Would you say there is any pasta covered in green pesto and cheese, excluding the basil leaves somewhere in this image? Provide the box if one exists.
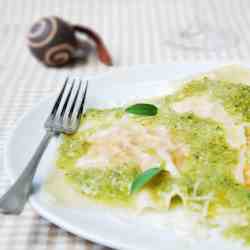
[56,67,250,245]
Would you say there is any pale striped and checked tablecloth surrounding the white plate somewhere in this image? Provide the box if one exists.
[0,0,250,250]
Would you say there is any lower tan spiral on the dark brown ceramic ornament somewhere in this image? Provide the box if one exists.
[44,43,74,66]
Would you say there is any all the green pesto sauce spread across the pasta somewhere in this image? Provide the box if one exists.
[57,78,250,243]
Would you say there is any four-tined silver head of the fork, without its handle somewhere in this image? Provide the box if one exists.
[45,77,88,134]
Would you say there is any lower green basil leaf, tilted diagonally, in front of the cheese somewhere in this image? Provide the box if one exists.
[130,167,164,193]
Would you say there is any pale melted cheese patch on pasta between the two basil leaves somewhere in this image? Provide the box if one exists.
[77,116,180,175]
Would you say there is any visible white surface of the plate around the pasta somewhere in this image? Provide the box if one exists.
[5,63,247,250]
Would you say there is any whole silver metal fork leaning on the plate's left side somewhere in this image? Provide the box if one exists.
[0,78,88,214]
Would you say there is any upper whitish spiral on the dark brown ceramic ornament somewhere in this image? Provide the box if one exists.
[28,17,58,48]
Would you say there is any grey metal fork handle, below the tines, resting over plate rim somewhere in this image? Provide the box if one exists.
[0,131,55,214]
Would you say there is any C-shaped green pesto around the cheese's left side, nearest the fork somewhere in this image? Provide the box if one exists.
[56,108,140,205]
